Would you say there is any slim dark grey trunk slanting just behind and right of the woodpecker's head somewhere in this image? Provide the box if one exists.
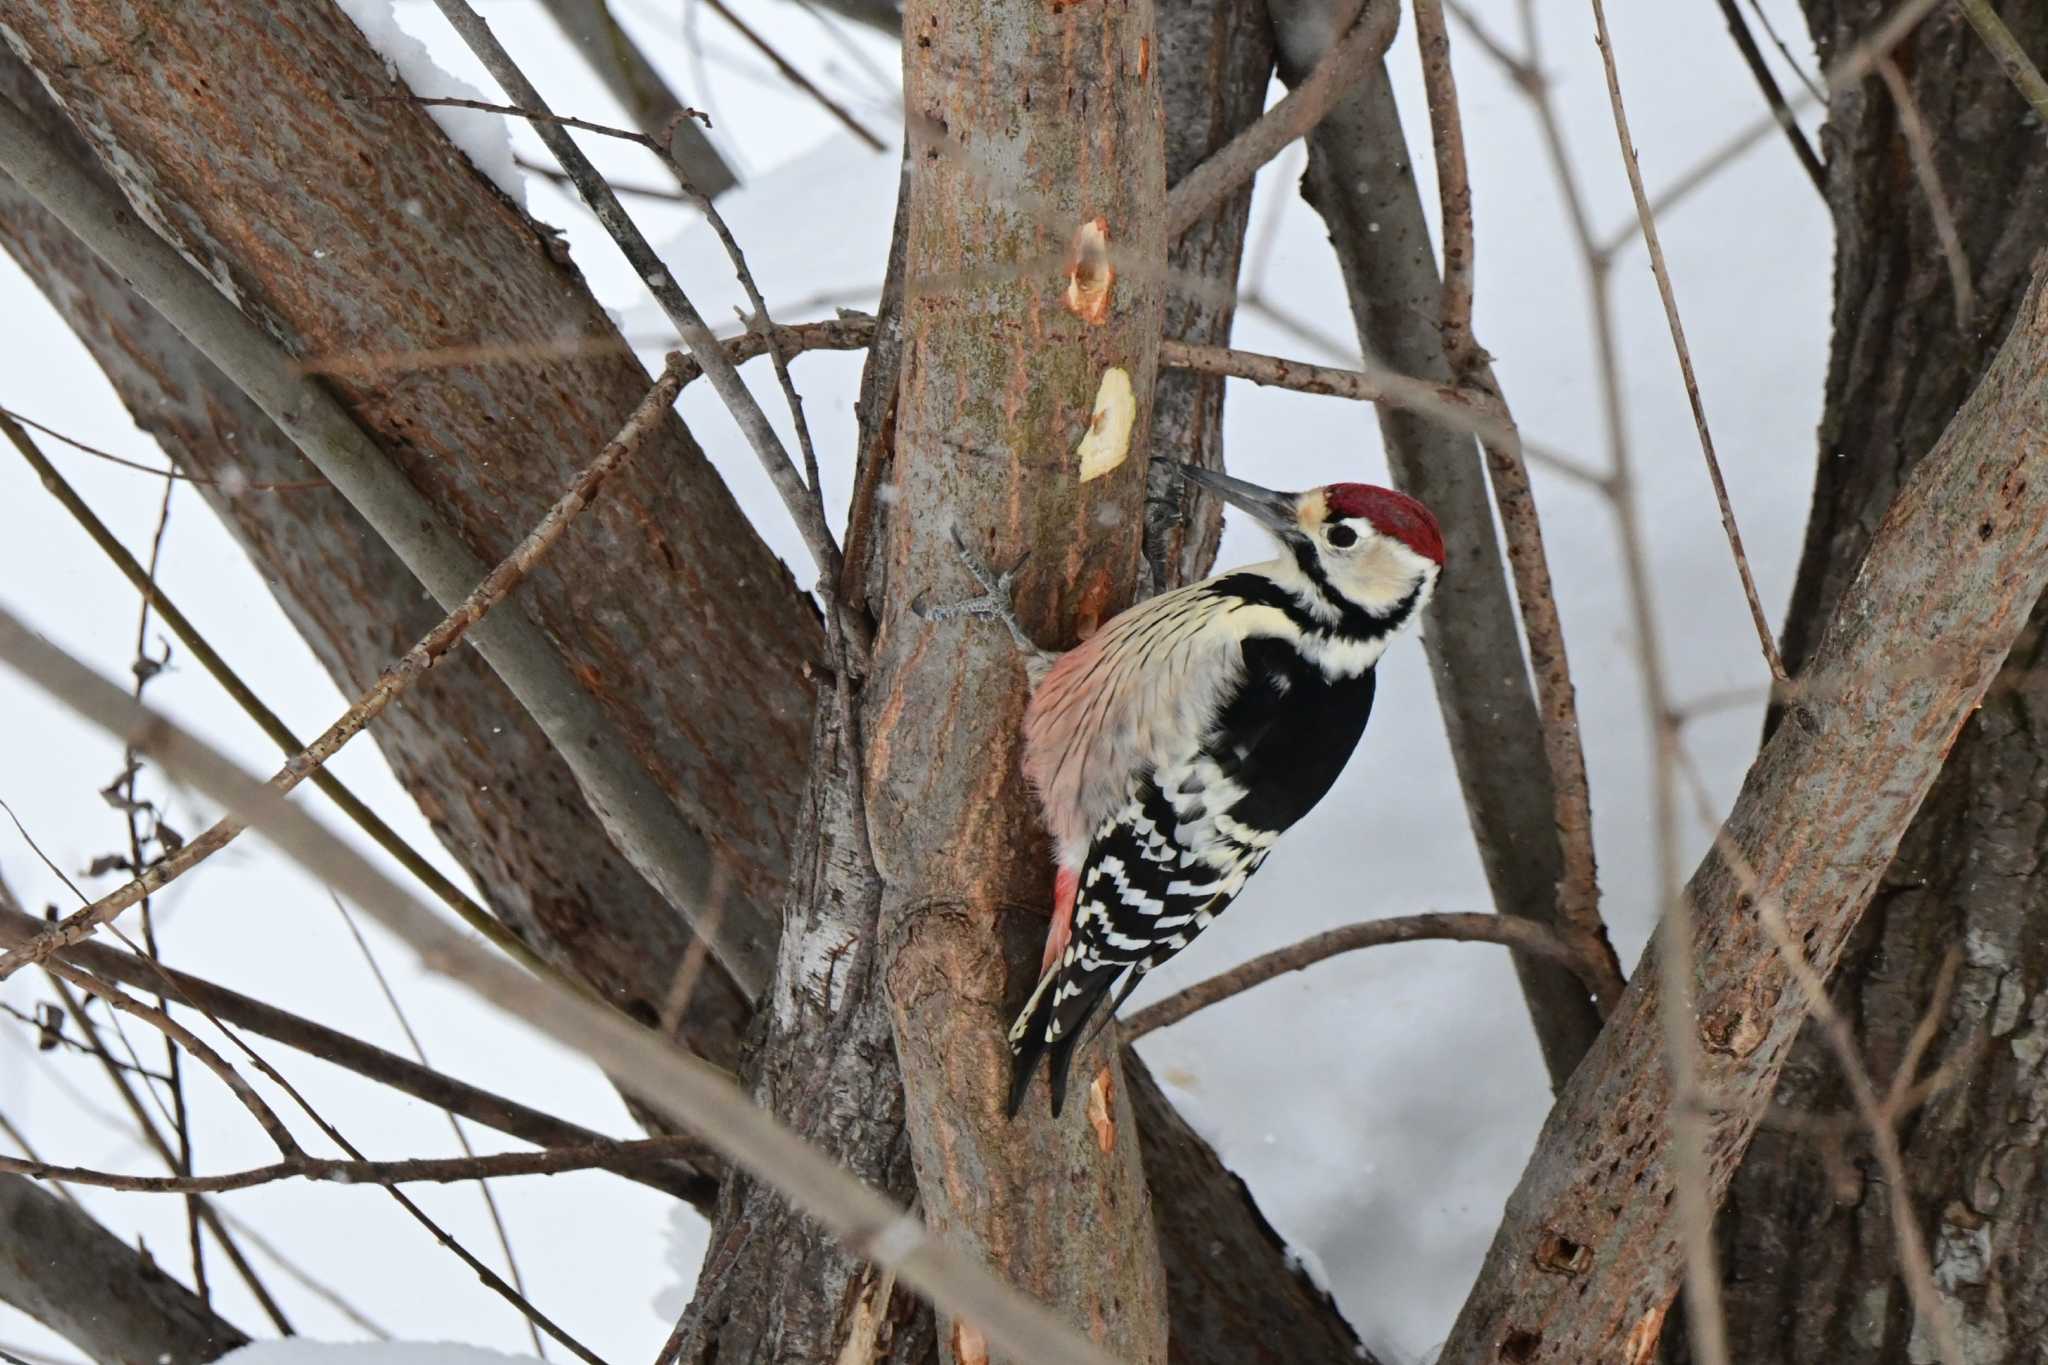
[1268,0,1599,1087]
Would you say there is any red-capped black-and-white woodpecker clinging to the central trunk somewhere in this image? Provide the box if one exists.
[1004,465,1444,1117]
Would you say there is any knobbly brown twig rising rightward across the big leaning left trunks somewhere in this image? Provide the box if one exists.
[0,360,682,980]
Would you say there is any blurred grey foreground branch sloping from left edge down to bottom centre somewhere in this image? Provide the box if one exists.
[0,626,1138,1365]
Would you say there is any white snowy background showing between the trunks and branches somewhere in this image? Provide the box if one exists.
[0,0,1829,1365]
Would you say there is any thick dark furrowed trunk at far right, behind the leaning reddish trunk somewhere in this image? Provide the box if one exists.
[1695,0,2048,1365]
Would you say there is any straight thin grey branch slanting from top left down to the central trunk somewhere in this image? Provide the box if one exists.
[434,0,840,597]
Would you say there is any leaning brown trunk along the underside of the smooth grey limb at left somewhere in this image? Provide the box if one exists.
[0,51,748,1064]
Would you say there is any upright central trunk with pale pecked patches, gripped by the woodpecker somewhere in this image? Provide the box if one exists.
[866,0,1165,1365]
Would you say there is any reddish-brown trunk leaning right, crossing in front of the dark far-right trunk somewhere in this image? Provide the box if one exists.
[1440,274,2048,1365]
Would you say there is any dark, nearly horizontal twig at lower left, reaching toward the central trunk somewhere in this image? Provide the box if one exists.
[0,1138,720,1195]
